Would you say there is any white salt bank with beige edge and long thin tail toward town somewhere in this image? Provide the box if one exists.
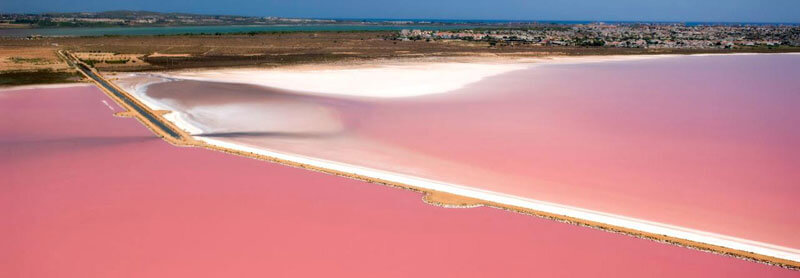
[155,55,708,98]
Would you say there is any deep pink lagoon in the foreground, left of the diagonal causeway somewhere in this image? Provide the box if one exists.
[0,87,799,278]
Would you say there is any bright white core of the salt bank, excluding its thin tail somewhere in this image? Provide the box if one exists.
[169,63,527,98]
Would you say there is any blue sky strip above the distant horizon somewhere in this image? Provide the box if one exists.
[0,0,800,23]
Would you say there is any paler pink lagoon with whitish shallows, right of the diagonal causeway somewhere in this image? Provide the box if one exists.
[141,55,800,248]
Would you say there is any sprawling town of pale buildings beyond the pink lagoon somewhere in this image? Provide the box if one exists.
[397,23,800,49]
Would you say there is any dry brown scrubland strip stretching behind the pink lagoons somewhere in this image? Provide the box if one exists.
[0,31,800,71]
